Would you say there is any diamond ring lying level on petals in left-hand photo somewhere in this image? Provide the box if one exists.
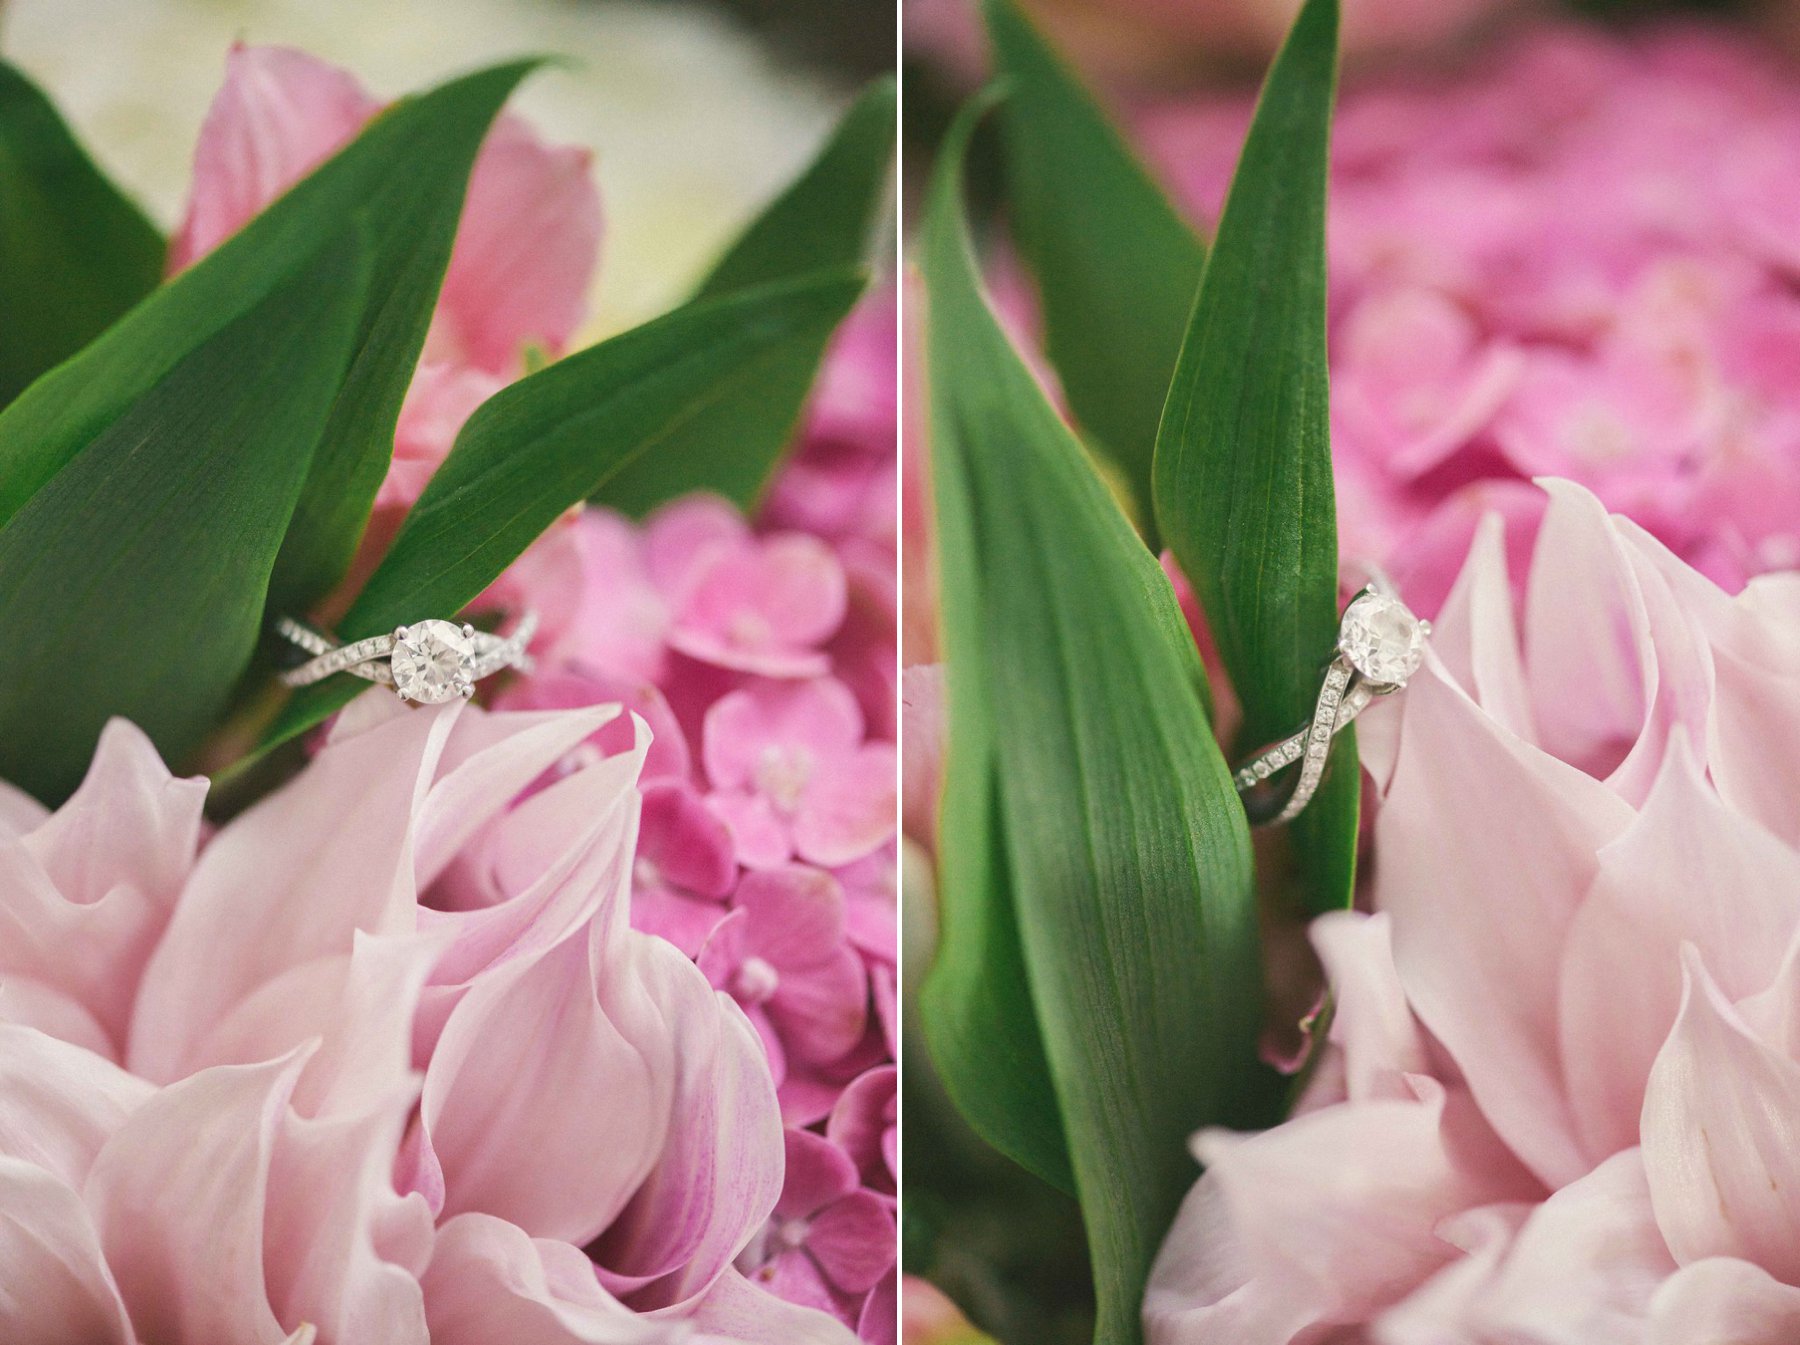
[275,612,538,706]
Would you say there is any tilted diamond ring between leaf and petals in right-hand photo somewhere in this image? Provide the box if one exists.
[1231,583,1431,823]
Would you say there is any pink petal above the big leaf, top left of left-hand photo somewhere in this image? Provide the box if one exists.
[169,45,380,270]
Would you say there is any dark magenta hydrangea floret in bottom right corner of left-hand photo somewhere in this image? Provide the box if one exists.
[747,1131,895,1325]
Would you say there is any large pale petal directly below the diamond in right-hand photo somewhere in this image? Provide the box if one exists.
[1373,655,1633,1185]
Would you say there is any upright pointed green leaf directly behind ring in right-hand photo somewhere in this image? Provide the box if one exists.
[1156,0,1359,911]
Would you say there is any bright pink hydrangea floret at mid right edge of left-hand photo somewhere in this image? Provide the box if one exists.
[702,677,895,868]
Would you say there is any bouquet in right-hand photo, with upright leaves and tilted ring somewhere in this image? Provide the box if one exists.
[905,0,1800,1345]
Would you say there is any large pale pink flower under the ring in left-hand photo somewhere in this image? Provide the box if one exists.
[0,691,853,1345]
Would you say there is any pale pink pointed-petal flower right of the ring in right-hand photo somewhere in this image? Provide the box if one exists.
[1145,481,1800,1345]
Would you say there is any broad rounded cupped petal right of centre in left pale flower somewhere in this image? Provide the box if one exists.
[423,925,675,1244]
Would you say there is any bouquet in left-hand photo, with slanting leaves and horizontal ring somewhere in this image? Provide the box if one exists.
[0,31,896,1345]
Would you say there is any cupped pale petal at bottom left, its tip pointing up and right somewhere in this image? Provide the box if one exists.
[85,1055,304,1345]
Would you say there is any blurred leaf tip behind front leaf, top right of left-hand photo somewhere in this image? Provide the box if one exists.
[695,77,895,299]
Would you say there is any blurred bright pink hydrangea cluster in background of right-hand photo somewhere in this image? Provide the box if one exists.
[1141,27,1800,610]
